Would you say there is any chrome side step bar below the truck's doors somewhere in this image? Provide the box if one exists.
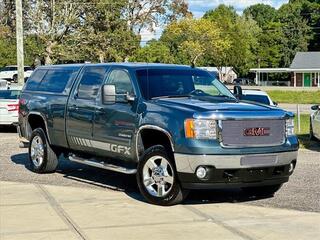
[69,155,137,174]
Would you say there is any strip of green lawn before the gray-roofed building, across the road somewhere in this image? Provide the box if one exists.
[267,90,320,104]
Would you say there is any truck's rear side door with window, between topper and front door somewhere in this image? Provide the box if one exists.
[66,66,108,152]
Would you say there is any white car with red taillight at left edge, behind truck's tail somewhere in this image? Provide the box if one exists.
[0,88,21,125]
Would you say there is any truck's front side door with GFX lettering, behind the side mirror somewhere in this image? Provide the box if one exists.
[93,67,138,160]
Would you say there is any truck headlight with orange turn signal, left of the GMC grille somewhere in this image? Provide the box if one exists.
[184,119,217,139]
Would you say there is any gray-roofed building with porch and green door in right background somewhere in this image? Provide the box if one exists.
[250,52,320,87]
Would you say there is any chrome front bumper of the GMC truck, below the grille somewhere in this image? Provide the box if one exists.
[174,151,298,173]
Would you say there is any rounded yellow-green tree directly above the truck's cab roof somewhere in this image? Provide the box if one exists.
[130,40,175,63]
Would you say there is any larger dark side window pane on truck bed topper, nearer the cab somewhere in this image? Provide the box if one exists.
[37,69,73,93]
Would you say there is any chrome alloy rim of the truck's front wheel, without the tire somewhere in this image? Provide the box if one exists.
[143,156,174,197]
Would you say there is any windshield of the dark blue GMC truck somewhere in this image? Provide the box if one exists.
[136,69,236,101]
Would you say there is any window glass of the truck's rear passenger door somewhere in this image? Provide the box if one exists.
[78,66,107,99]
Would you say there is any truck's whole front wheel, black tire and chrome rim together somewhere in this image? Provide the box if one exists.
[137,145,187,206]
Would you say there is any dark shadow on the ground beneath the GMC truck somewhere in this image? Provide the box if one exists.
[11,153,272,204]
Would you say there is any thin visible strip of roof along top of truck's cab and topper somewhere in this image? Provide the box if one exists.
[38,62,192,69]
